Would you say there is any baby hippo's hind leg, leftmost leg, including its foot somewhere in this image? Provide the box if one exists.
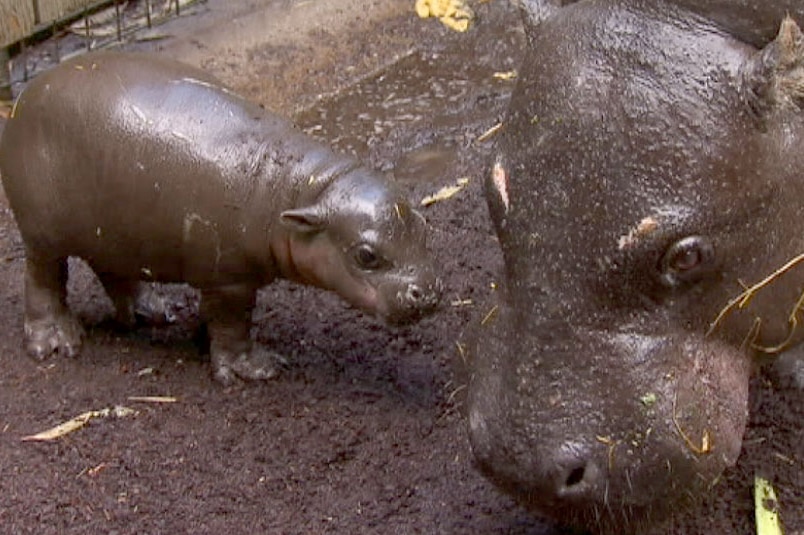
[25,254,84,360]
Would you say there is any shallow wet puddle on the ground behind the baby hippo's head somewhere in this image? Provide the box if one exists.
[295,35,516,186]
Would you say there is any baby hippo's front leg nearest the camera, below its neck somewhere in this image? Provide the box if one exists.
[201,285,276,385]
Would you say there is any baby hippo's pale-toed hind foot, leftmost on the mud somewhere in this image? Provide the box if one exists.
[25,312,84,360]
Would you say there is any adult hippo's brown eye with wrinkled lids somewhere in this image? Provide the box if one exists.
[659,236,715,287]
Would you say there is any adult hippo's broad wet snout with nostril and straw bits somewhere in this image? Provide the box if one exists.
[468,311,750,532]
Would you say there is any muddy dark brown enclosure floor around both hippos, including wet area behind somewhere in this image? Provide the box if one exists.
[0,0,804,535]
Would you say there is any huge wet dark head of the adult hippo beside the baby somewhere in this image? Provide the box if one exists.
[467,0,804,534]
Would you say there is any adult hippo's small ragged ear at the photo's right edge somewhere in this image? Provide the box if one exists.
[744,16,804,119]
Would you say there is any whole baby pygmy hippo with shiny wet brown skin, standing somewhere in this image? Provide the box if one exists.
[0,53,441,383]
